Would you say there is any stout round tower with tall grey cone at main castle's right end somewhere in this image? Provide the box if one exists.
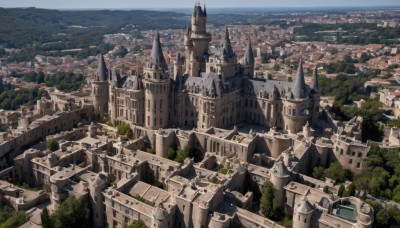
[282,60,310,133]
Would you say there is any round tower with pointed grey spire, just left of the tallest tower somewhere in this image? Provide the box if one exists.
[143,32,171,130]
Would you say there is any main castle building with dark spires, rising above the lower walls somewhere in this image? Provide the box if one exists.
[92,4,320,133]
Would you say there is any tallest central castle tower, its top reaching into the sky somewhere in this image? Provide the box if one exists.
[185,2,211,77]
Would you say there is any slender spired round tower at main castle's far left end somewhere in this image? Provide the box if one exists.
[92,55,109,117]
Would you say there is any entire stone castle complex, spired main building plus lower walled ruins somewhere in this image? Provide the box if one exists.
[0,4,376,228]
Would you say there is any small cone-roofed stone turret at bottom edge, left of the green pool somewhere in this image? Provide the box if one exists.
[293,197,314,228]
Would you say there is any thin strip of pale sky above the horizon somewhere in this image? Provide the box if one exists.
[0,0,400,10]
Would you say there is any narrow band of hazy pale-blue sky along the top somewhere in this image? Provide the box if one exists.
[0,0,400,9]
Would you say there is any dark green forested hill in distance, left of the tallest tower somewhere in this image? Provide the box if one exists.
[0,8,187,48]
